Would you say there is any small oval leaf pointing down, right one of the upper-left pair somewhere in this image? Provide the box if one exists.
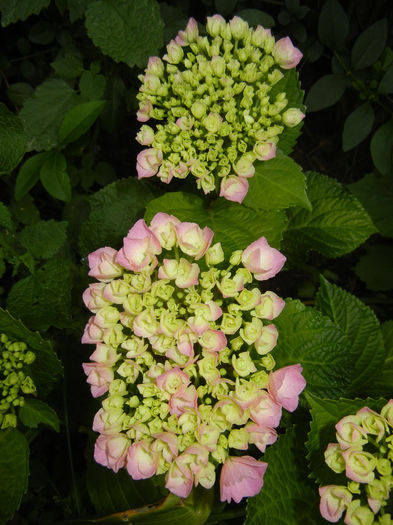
[40,151,71,201]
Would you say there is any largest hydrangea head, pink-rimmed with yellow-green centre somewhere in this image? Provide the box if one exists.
[82,213,305,502]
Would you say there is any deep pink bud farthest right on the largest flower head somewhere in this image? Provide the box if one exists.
[268,364,306,412]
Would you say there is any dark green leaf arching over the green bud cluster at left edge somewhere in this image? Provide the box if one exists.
[0,306,63,396]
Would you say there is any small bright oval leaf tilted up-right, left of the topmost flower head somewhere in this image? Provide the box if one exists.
[59,100,105,144]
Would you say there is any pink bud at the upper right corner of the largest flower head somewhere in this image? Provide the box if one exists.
[242,237,286,281]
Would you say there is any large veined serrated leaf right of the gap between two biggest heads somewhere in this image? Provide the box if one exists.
[282,172,376,257]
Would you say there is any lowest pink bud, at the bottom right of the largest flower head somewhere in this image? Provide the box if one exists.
[220,456,267,503]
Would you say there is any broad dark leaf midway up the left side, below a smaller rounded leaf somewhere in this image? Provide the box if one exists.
[7,258,73,331]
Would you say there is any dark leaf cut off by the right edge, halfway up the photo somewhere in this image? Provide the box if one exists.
[348,173,393,237]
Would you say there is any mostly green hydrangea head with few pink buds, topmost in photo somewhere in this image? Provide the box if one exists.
[136,15,304,203]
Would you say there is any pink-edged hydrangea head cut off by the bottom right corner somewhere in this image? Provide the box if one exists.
[319,399,393,525]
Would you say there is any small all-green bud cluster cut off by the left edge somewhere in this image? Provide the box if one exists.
[0,334,36,429]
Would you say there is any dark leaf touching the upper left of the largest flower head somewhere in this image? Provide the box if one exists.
[79,178,153,255]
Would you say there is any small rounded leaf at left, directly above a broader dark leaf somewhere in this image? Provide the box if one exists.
[18,219,68,259]
